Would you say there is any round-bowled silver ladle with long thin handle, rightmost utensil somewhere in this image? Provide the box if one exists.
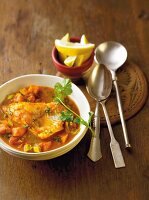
[95,41,131,148]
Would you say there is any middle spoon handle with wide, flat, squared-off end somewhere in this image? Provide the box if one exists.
[100,101,125,168]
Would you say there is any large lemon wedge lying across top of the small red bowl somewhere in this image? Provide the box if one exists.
[55,39,95,56]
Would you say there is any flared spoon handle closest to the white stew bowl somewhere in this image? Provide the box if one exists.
[87,101,102,162]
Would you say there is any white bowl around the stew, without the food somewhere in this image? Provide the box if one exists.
[0,74,90,160]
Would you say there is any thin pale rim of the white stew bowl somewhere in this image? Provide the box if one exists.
[0,74,90,157]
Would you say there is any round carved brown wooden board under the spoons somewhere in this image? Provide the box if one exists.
[101,62,148,124]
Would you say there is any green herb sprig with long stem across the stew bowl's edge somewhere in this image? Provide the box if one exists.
[54,79,95,136]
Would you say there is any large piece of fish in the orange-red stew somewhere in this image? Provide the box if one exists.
[2,102,65,139]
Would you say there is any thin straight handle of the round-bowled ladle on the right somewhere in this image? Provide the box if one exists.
[113,78,131,148]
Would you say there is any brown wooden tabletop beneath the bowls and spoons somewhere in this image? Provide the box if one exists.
[0,0,149,200]
